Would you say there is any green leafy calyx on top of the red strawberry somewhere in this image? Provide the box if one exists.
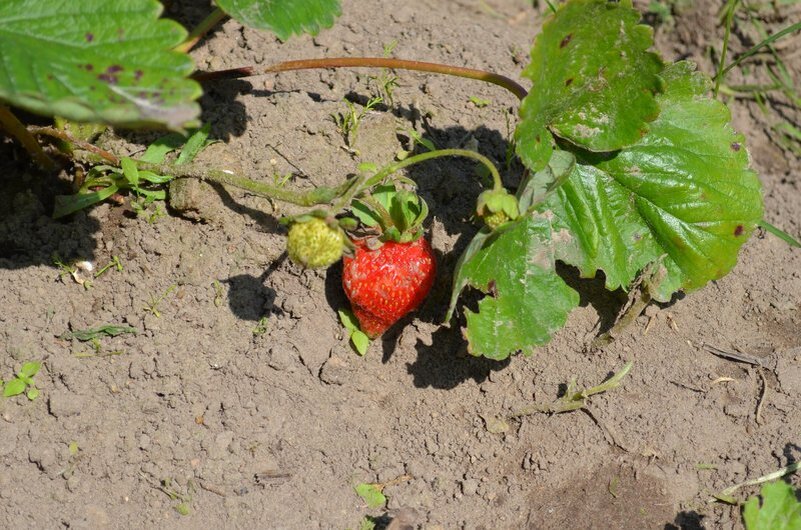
[351,184,428,243]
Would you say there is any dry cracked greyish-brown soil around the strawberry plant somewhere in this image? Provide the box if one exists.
[0,0,801,530]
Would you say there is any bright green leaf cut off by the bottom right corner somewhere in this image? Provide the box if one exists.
[743,481,801,530]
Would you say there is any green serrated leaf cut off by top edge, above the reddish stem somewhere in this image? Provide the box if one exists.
[217,0,341,41]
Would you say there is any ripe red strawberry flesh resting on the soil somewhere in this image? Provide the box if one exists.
[342,237,436,338]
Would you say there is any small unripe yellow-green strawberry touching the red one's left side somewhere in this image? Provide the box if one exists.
[286,217,345,269]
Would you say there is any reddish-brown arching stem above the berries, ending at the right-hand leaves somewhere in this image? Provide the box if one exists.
[192,57,528,100]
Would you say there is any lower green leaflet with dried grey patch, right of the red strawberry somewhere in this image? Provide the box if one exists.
[448,213,579,360]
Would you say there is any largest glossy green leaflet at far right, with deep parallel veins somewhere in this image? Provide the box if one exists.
[543,62,762,301]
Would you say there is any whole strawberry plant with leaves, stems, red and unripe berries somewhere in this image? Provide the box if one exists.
[0,0,780,359]
